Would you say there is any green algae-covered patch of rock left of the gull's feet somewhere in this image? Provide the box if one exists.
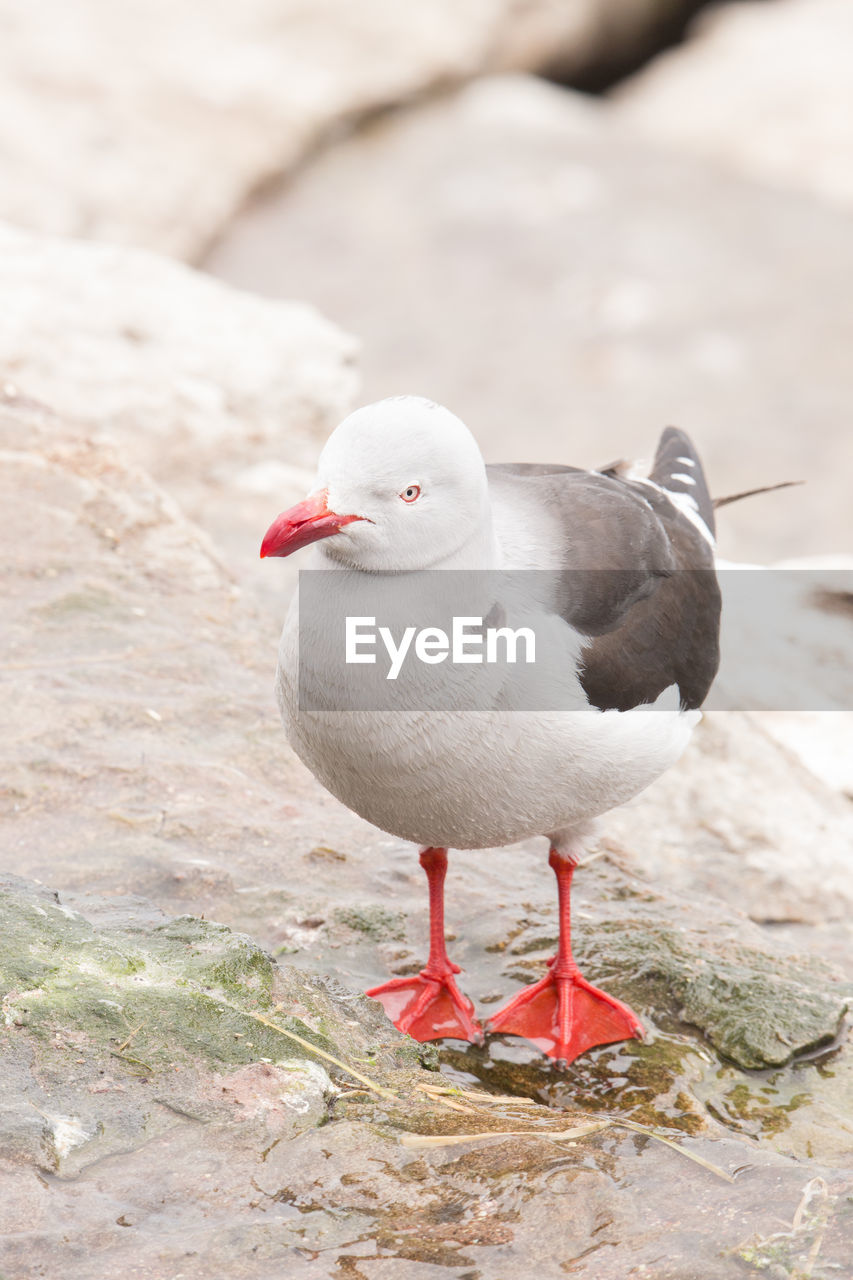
[0,876,422,1071]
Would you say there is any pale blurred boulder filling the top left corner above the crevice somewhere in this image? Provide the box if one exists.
[0,0,693,259]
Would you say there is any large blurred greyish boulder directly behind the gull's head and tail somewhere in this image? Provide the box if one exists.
[207,74,853,563]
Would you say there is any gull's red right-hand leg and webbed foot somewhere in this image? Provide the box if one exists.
[488,849,643,1062]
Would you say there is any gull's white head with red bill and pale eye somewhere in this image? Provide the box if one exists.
[261,396,489,571]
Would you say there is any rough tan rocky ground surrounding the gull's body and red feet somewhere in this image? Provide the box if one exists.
[0,257,853,1280]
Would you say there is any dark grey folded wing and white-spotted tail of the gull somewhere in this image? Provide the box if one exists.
[489,428,720,710]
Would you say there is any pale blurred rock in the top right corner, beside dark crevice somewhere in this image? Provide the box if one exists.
[613,0,853,209]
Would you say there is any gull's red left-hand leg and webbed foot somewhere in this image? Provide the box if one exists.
[366,849,483,1044]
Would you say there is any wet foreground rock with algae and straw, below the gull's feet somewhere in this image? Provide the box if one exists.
[0,877,849,1277]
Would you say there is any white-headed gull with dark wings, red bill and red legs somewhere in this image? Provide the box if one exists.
[261,396,720,1064]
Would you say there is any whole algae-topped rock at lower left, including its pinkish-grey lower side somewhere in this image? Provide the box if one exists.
[0,876,412,1178]
